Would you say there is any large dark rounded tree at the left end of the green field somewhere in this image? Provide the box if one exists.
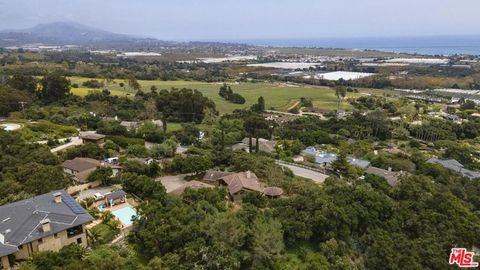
[40,73,70,103]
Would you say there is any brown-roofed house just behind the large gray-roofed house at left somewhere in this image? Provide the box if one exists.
[62,157,122,183]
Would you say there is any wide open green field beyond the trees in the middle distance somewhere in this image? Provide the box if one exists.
[70,77,361,113]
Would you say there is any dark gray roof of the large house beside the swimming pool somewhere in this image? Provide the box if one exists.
[0,190,93,254]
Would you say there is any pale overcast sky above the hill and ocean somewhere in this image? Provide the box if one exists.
[0,0,480,41]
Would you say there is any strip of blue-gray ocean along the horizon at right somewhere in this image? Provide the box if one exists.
[238,36,480,55]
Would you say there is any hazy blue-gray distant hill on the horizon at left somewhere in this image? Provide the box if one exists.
[0,22,163,47]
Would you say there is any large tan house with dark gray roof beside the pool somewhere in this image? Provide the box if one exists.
[0,190,93,269]
